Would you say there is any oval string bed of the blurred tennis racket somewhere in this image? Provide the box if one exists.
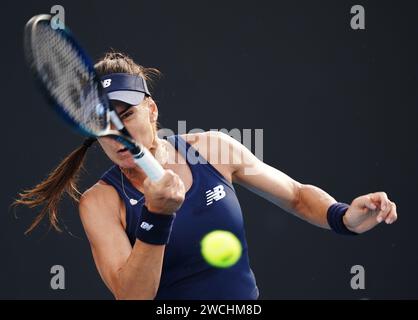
[32,23,108,135]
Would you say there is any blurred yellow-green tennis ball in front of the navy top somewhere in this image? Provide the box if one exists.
[200,230,242,268]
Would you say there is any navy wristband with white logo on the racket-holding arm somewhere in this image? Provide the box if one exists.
[135,205,176,245]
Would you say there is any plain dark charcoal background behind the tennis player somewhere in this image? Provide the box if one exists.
[0,0,418,299]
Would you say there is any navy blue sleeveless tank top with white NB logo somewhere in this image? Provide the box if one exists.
[101,135,259,300]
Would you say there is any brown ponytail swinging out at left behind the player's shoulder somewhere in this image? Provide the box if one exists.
[12,138,95,234]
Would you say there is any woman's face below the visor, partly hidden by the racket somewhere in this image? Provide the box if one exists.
[98,98,157,168]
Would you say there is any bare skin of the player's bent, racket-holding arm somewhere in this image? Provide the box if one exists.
[79,172,184,299]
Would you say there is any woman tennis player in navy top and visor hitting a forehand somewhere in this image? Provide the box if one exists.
[16,52,397,299]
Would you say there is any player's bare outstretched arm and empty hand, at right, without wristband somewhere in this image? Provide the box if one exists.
[211,133,397,233]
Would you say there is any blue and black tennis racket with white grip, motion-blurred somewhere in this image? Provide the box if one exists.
[24,14,164,181]
